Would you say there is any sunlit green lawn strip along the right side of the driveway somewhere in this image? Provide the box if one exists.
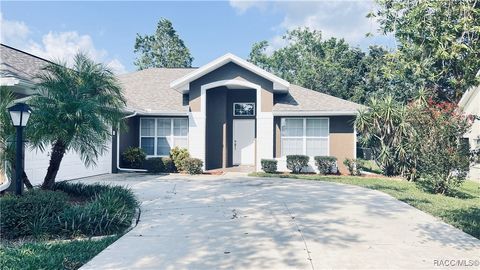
[250,173,480,239]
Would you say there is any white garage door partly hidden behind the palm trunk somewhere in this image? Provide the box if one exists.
[25,141,112,185]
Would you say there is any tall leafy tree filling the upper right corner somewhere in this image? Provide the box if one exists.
[376,0,480,102]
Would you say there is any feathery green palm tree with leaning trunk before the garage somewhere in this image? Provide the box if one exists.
[27,53,125,189]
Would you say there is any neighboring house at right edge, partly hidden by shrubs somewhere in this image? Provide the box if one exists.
[458,86,480,180]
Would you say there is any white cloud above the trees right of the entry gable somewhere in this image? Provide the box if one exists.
[230,1,393,49]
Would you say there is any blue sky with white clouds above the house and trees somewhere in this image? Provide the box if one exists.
[0,0,394,73]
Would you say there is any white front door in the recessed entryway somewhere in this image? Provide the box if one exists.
[232,119,255,165]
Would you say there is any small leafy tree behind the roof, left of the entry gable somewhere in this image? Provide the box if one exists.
[134,18,193,70]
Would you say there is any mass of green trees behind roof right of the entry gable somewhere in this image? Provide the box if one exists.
[249,28,412,103]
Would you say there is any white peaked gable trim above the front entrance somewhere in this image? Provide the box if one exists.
[170,53,290,92]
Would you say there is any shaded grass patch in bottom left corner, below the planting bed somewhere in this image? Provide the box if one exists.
[0,236,119,270]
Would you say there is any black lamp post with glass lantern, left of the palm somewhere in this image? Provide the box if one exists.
[8,103,30,195]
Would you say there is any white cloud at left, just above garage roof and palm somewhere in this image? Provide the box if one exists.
[0,13,126,74]
